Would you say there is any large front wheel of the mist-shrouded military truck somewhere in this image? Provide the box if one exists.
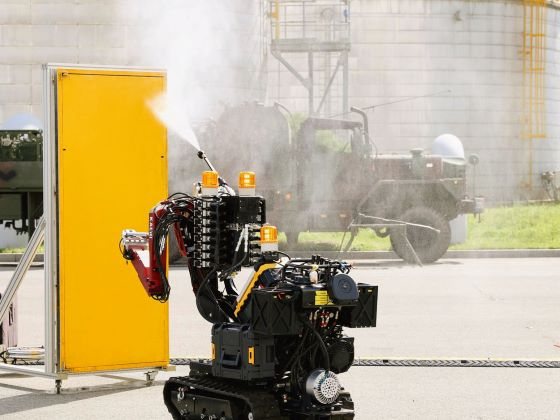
[390,207,451,263]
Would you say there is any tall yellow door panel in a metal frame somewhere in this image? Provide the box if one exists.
[57,68,169,372]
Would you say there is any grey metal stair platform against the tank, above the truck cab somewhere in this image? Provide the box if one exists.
[268,0,350,115]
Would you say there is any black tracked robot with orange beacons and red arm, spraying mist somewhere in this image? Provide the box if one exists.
[121,152,377,420]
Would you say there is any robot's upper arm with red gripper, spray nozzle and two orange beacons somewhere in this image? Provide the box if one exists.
[120,151,265,322]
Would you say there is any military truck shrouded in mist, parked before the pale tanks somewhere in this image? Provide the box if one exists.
[201,103,483,262]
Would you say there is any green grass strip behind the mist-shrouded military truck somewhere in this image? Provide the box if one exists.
[280,204,560,251]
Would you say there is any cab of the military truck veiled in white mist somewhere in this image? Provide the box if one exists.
[268,118,374,235]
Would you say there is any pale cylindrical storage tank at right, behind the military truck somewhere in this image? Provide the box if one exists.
[269,0,560,202]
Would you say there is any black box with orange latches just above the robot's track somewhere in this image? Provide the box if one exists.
[212,323,274,381]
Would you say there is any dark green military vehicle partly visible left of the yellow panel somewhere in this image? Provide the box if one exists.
[0,130,43,237]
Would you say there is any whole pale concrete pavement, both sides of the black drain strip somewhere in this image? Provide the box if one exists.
[0,258,560,419]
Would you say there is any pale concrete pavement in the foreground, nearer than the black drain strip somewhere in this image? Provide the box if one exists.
[0,367,560,420]
